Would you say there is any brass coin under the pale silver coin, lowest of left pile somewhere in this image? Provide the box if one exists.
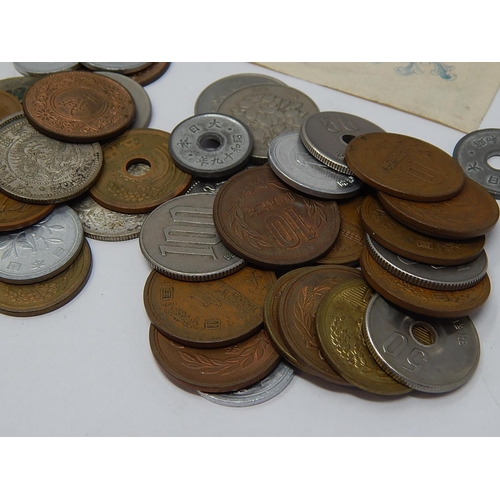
[0,240,92,316]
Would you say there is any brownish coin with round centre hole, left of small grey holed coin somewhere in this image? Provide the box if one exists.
[90,129,191,214]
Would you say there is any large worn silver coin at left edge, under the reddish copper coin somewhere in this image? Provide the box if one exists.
[0,113,102,204]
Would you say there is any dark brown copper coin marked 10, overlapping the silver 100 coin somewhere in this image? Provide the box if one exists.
[214,165,340,268]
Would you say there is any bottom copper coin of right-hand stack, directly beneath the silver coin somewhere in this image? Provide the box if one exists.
[360,247,491,318]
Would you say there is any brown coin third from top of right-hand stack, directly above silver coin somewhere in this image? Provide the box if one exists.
[361,195,486,266]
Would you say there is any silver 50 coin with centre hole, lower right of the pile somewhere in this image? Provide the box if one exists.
[363,294,480,393]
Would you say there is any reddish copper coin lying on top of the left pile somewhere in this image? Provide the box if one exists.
[23,71,135,142]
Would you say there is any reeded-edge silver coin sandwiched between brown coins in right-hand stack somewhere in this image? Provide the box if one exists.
[366,234,488,290]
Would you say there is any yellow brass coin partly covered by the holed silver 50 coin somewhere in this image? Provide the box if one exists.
[316,279,411,396]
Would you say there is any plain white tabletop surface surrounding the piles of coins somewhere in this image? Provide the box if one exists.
[0,63,500,436]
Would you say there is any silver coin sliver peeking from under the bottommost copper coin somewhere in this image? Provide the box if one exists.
[198,361,294,407]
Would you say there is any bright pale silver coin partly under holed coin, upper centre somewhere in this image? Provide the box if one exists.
[269,132,364,199]
